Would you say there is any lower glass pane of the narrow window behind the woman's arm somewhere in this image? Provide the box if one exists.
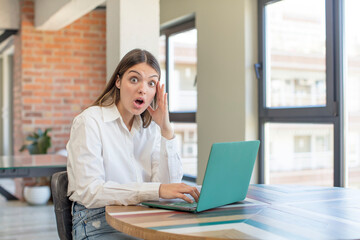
[173,123,197,176]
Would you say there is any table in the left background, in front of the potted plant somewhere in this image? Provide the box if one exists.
[0,154,67,200]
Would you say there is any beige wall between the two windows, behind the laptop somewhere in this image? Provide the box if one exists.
[160,0,258,183]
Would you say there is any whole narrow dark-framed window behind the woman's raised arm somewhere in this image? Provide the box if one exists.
[159,18,197,181]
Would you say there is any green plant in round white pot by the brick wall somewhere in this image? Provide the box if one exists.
[20,128,51,205]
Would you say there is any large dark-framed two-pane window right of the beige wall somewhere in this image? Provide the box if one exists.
[255,0,344,186]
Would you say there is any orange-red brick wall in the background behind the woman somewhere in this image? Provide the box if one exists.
[13,0,106,155]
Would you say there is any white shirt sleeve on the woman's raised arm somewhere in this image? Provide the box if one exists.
[151,125,183,183]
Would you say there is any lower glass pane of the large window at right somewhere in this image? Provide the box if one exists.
[265,123,334,186]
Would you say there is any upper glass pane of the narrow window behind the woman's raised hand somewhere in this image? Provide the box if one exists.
[169,29,197,112]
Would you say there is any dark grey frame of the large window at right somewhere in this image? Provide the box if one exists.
[255,0,346,187]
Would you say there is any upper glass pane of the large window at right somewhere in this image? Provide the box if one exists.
[265,0,326,108]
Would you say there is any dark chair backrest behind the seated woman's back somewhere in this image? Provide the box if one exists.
[51,171,72,240]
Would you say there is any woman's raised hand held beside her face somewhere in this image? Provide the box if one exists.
[147,82,174,139]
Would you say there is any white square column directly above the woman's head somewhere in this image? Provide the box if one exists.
[106,0,160,80]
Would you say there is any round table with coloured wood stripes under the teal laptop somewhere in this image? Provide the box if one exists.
[106,184,360,240]
